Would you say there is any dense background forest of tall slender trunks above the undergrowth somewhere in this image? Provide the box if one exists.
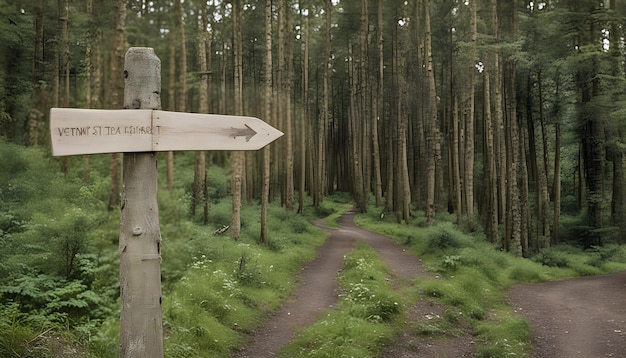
[0,0,626,255]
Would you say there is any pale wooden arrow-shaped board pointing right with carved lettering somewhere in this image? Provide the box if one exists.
[50,108,283,157]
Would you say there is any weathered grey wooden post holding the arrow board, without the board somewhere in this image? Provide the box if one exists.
[119,47,163,358]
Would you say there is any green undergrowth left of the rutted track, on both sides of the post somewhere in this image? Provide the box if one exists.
[0,140,356,358]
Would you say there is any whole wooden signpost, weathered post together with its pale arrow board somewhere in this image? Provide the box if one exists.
[50,47,283,358]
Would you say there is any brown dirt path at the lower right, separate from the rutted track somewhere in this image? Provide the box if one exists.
[509,272,626,358]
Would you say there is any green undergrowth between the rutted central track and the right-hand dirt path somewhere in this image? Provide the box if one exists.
[355,213,626,357]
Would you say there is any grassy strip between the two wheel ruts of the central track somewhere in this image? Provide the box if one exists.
[279,243,402,358]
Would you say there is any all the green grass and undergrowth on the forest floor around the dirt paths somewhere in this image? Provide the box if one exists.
[0,142,626,357]
